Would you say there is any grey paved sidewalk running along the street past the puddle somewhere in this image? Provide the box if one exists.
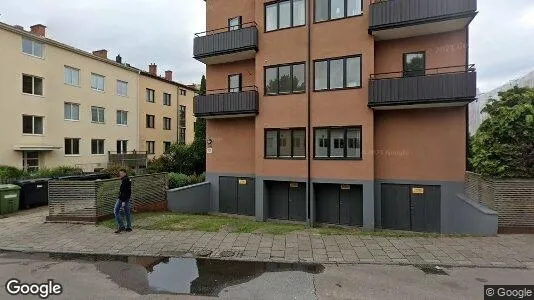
[0,208,534,268]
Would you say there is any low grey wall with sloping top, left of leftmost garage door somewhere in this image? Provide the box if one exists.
[167,181,210,213]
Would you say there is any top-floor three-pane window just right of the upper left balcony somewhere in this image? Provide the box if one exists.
[265,0,306,31]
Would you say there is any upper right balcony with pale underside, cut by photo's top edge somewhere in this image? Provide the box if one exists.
[369,0,477,40]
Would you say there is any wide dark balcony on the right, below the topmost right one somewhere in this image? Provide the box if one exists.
[368,65,477,110]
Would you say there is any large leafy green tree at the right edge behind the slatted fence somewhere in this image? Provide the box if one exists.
[470,86,534,178]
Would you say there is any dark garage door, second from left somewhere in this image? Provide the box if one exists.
[265,181,306,221]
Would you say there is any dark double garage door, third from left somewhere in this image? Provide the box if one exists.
[314,184,363,226]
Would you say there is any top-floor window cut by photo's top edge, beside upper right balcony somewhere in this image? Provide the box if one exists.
[315,0,363,22]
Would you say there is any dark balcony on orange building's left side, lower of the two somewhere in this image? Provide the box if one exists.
[193,86,259,119]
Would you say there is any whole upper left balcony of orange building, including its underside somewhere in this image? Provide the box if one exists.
[193,22,258,65]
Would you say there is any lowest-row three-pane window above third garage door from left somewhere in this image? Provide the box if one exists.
[315,127,362,159]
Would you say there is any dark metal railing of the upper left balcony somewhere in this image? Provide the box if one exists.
[193,22,258,59]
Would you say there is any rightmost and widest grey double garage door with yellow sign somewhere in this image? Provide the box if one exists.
[381,184,441,232]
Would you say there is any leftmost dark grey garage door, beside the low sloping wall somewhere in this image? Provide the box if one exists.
[219,177,256,216]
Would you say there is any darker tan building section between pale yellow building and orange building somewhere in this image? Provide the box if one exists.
[139,64,197,158]
